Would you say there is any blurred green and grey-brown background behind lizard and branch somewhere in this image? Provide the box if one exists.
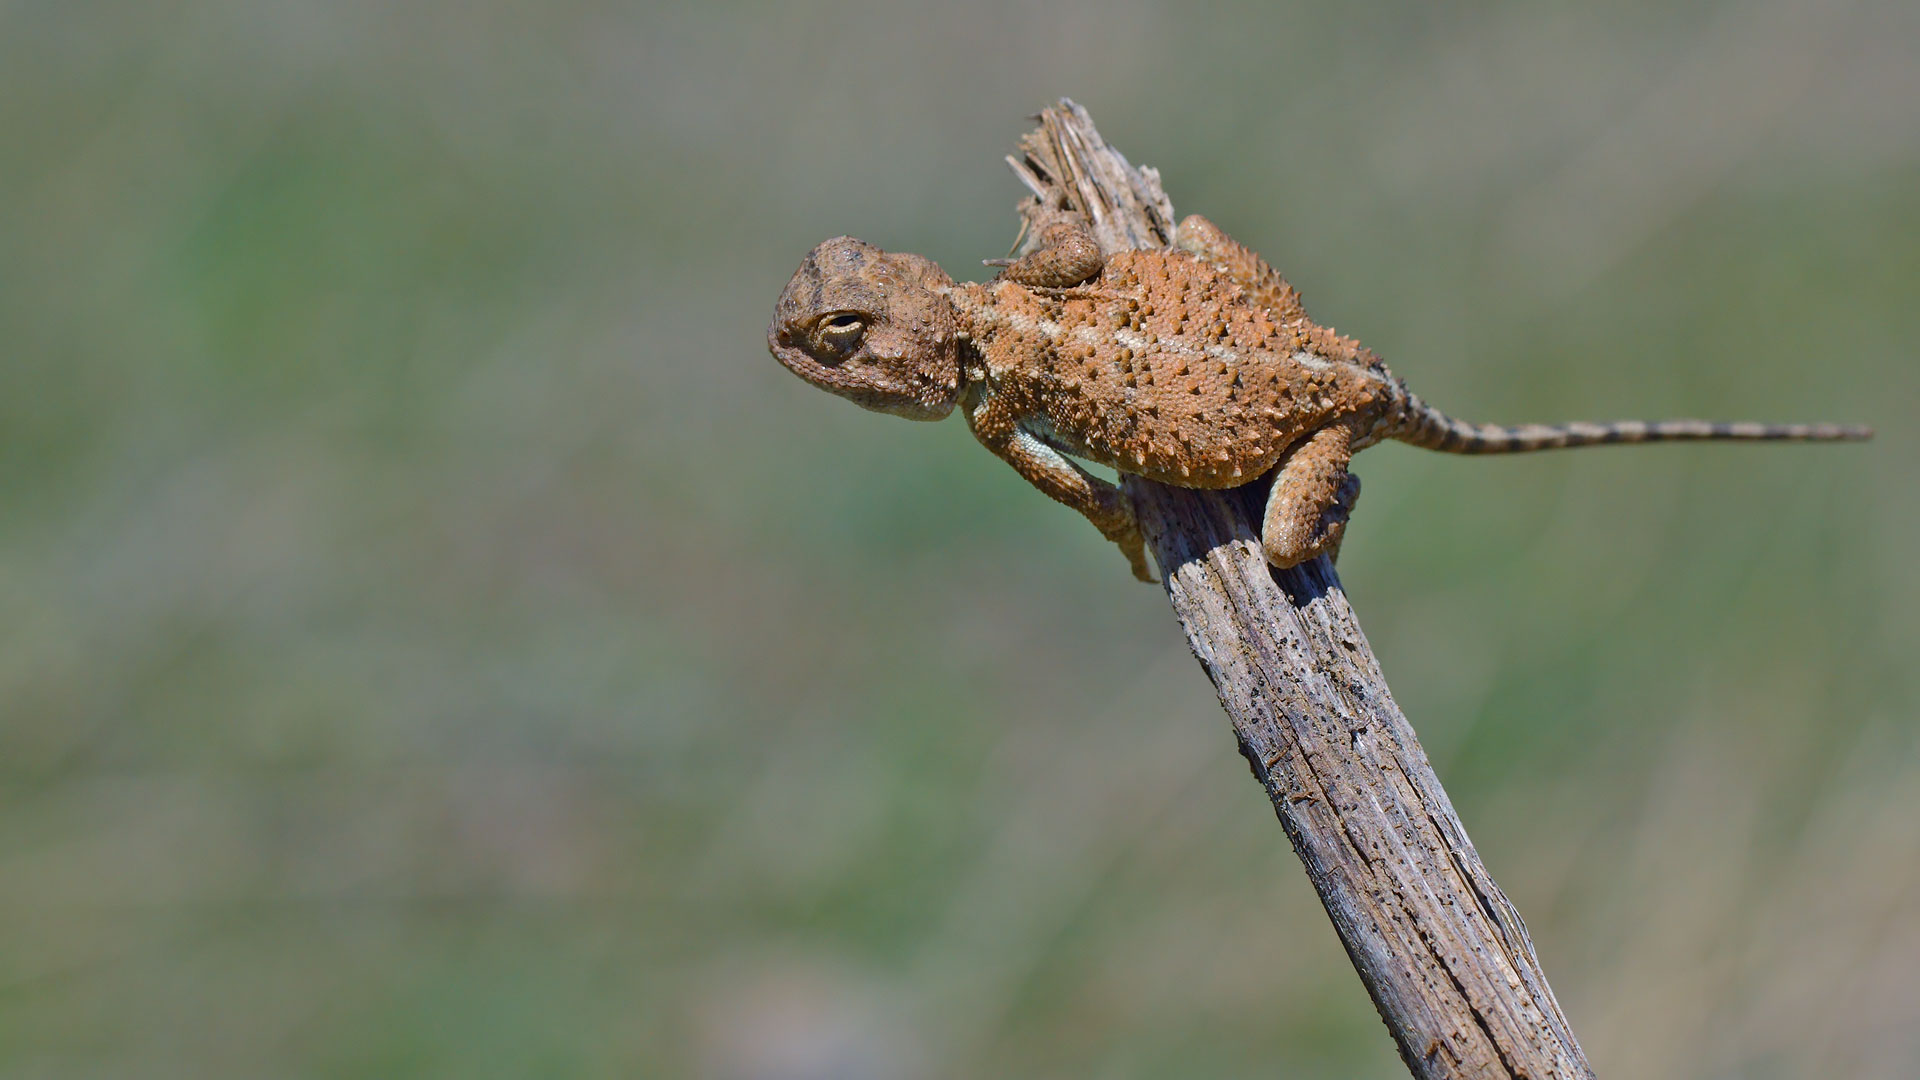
[0,0,1920,1080]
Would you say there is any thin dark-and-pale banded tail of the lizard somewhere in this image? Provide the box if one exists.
[1390,394,1874,454]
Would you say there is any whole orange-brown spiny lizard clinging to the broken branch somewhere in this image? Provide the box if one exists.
[766,215,1872,580]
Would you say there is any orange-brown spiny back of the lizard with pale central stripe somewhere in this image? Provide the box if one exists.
[956,250,1402,488]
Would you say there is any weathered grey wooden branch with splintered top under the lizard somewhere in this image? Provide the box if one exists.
[1008,100,1594,1080]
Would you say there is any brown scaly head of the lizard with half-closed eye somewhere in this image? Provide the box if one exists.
[766,236,960,421]
